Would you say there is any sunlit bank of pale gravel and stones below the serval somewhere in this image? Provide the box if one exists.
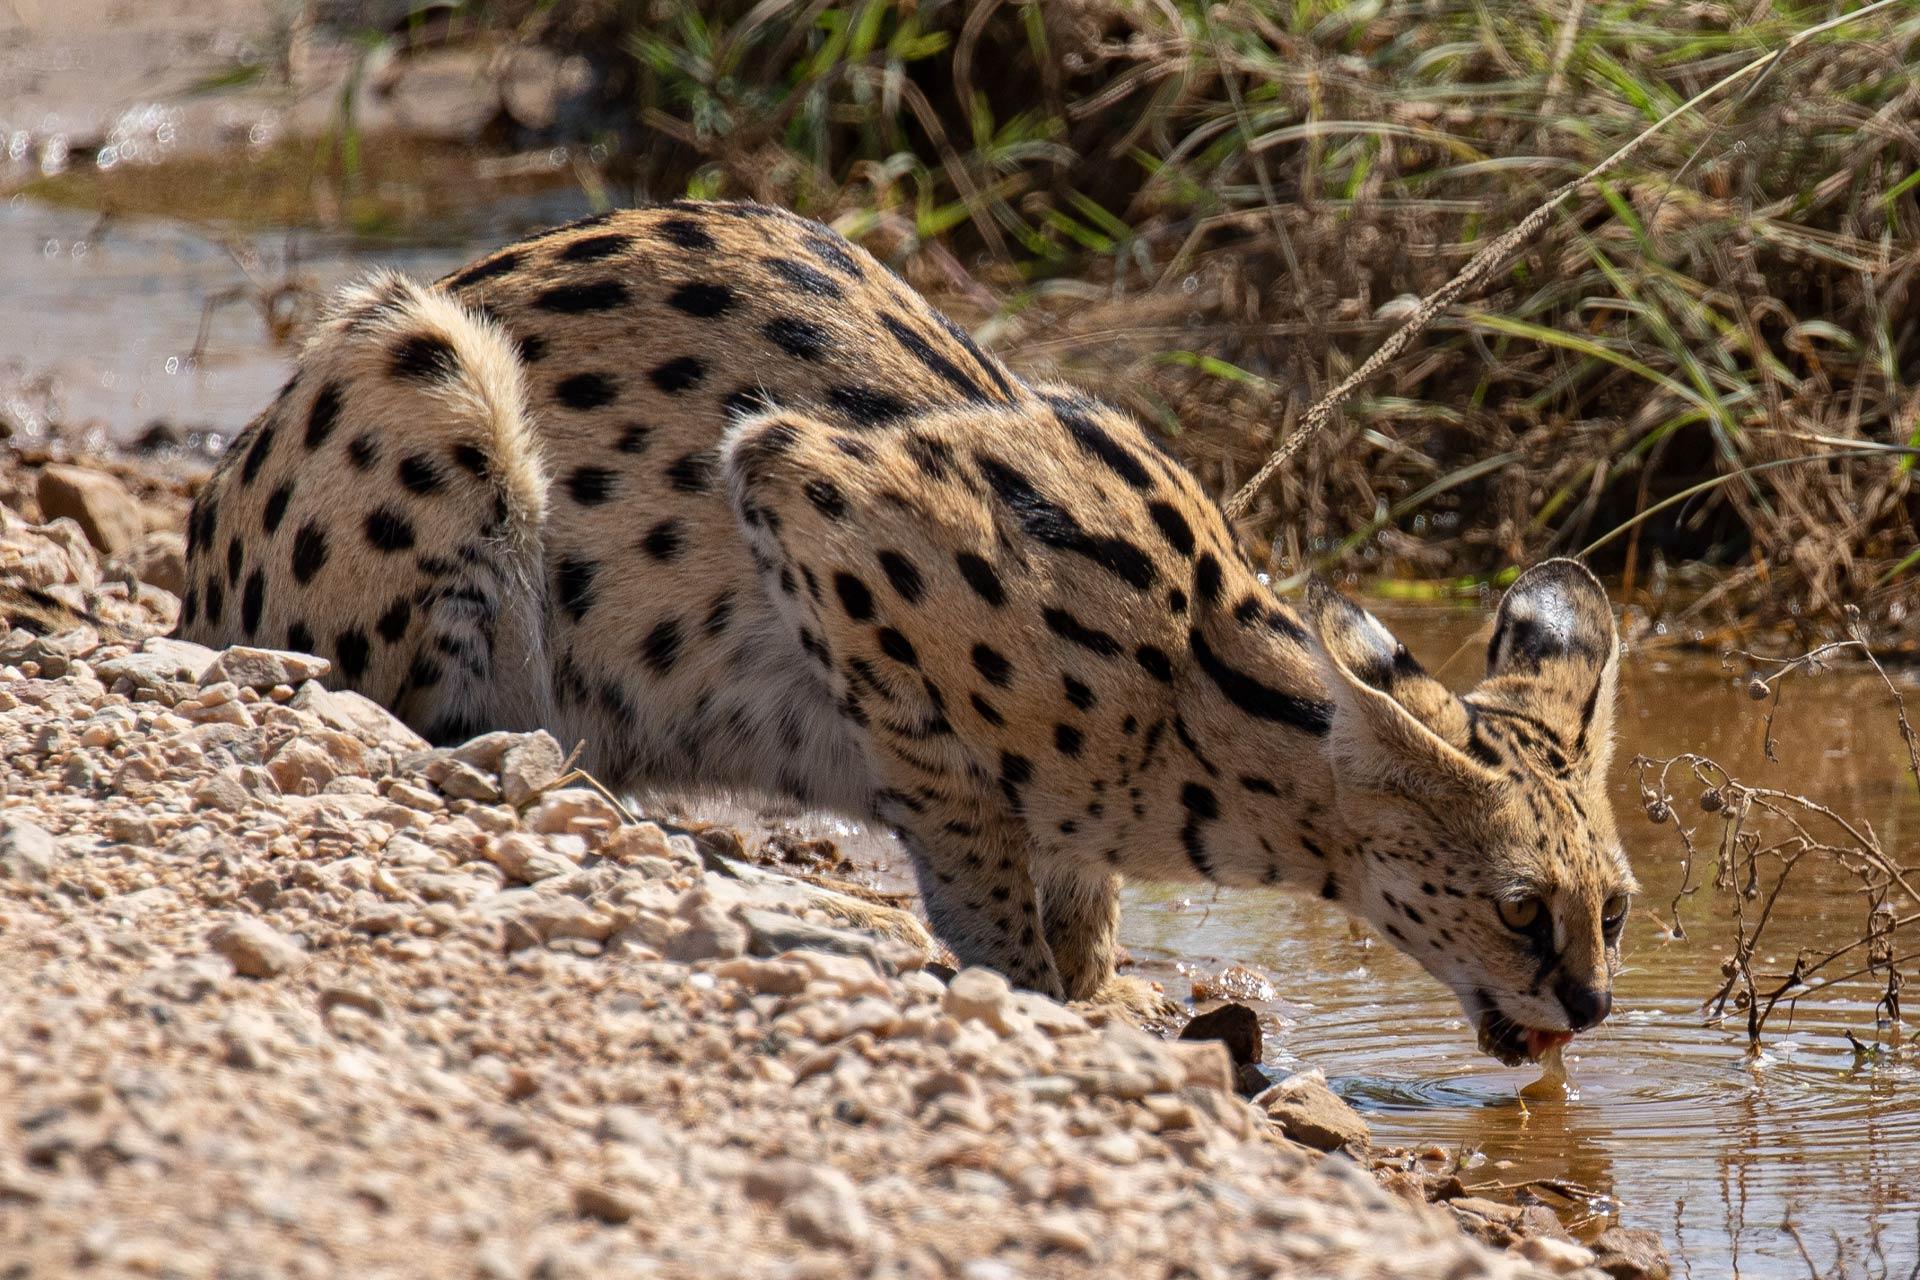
[0,443,1659,1280]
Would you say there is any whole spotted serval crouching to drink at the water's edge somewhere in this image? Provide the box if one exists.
[180,201,1630,1057]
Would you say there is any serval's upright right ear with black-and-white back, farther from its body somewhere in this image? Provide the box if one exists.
[1473,560,1620,773]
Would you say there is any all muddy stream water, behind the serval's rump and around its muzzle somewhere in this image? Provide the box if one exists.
[0,185,1920,1278]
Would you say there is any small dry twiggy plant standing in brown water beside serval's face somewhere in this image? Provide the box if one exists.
[1634,614,1920,1057]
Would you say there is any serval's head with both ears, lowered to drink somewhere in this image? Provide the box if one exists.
[1308,560,1636,1065]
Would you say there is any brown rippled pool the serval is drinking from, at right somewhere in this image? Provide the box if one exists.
[1125,610,1920,1276]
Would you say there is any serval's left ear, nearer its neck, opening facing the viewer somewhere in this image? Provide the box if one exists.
[1308,578,1498,796]
